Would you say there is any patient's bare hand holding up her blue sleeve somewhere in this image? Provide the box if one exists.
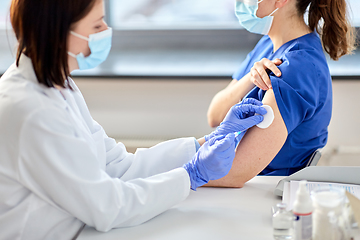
[250,58,282,91]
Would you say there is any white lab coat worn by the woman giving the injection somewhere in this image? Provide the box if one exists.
[0,55,196,240]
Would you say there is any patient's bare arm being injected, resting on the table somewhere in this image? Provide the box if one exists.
[208,89,288,187]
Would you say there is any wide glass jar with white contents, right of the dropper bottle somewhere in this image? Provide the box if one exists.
[311,188,351,240]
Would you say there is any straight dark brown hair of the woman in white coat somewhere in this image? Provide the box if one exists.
[10,0,97,88]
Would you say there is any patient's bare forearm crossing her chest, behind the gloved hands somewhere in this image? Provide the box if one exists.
[207,74,254,127]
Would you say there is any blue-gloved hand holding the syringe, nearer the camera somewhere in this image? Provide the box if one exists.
[183,133,235,190]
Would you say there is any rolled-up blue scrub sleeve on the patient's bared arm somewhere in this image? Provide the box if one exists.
[270,53,319,134]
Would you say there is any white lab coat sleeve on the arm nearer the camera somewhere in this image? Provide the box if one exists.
[18,108,190,231]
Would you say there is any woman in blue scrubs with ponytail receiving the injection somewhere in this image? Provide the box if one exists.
[208,0,354,187]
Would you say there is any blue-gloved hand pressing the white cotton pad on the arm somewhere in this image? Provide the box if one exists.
[205,98,266,145]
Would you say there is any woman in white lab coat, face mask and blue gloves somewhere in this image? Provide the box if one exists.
[0,0,266,240]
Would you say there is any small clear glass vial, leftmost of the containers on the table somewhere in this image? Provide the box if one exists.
[272,203,294,240]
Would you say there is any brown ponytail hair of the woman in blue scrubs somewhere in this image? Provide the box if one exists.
[296,0,355,60]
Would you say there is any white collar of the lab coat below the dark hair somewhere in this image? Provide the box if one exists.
[18,54,67,108]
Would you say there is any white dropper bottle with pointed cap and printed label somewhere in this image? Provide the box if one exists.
[293,180,313,240]
